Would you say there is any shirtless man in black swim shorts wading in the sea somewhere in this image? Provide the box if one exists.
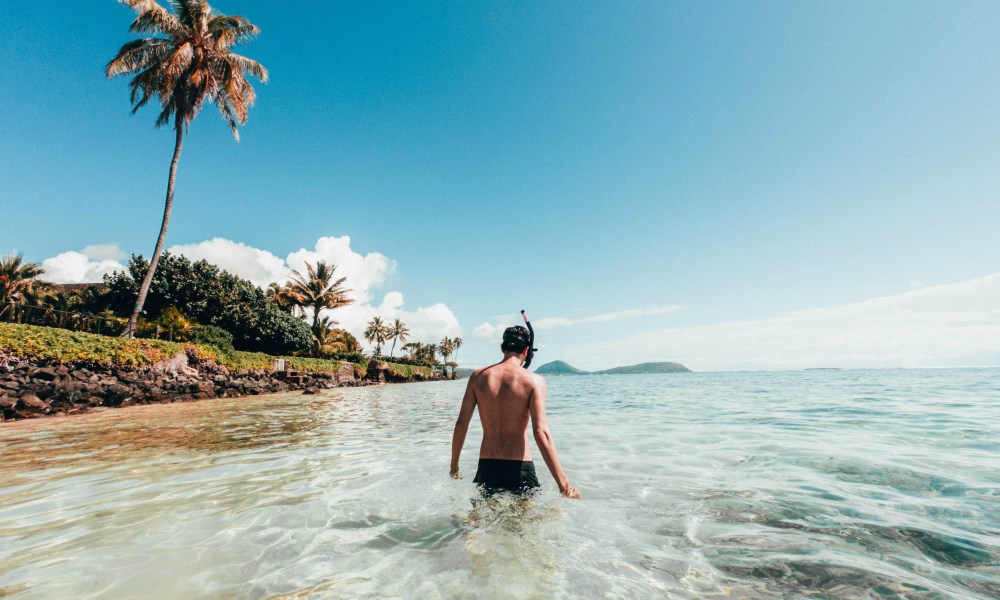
[451,326,580,498]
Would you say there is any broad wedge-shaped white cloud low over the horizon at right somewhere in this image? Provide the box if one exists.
[564,273,1000,370]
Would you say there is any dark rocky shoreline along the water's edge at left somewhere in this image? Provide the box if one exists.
[0,353,444,421]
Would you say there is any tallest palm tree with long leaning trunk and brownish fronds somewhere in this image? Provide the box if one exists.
[105,0,267,337]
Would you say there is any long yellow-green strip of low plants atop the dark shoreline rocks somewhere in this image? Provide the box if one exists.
[0,323,368,373]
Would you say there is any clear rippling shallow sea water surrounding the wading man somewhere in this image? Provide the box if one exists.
[0,369,1000,599]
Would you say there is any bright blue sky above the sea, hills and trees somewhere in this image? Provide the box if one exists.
[0,0,1000,369]
